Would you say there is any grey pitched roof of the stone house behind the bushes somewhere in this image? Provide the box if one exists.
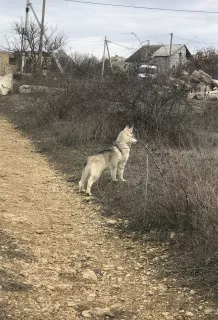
[126,44,191,62]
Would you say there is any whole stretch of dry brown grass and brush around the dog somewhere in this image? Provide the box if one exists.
[2,70,218,293]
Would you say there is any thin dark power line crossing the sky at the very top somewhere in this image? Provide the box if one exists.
[64,0,218,14]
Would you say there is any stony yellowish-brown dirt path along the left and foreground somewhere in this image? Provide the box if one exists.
[0,118,218,320]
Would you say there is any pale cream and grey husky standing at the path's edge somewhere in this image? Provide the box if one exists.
[79,126,137,196]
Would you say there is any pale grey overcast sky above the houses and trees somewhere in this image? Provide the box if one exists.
[0,0,218,57]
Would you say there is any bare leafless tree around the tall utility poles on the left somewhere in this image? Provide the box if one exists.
[6,20,66,74]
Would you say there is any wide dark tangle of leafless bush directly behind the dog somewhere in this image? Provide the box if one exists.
[22,74,191,145]
